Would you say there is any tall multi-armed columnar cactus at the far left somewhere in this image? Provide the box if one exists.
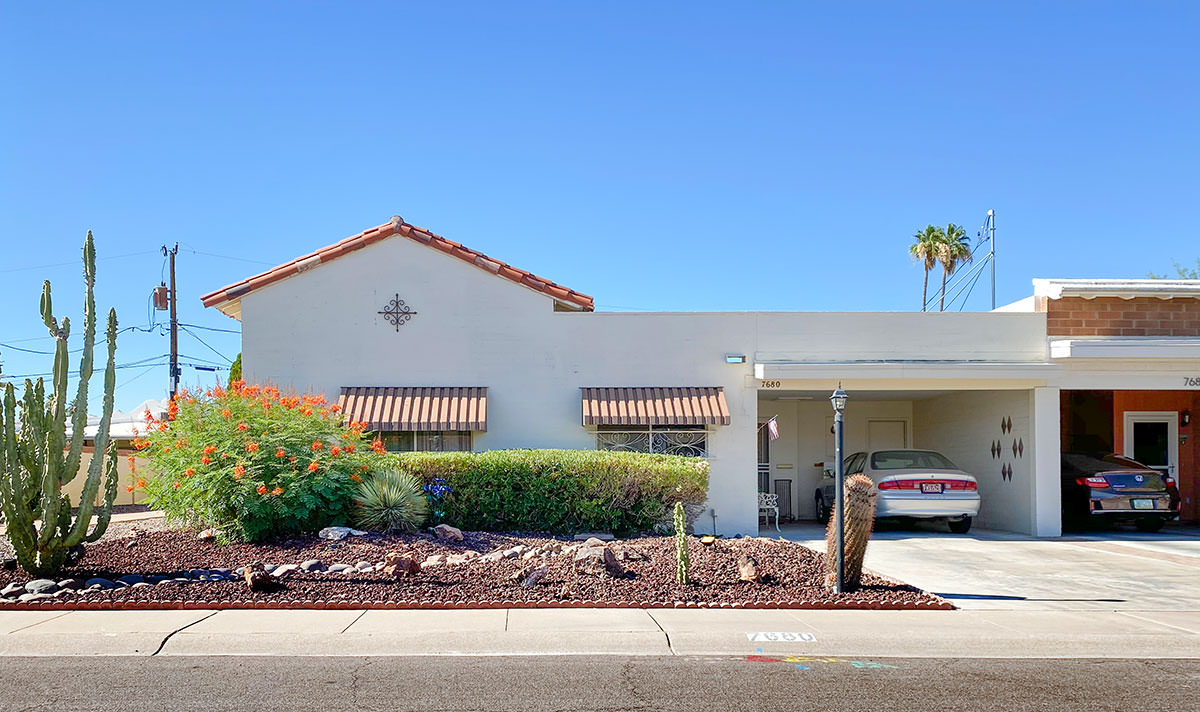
[0,232,118,575]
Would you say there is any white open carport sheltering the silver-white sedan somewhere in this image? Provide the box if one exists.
[755,361,1061,537]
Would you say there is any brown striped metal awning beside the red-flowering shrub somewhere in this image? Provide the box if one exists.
[337,387,487,431]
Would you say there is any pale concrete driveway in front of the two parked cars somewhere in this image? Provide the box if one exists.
[782,523,1200,611]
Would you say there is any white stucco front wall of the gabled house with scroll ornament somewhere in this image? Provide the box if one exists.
[241,238,1057,534]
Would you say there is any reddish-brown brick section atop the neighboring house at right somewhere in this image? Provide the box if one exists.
[1044,297,1200,336]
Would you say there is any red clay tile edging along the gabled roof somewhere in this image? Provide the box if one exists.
[200,217,595,311]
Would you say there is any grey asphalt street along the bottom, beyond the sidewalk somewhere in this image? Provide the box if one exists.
[0,654,1200,712]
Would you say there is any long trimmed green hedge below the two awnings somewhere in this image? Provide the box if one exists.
[395,450,708,536]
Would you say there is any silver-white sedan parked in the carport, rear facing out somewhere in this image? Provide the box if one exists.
[814,450,979,534]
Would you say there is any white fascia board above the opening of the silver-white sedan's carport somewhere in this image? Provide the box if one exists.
[754,361,1061,381]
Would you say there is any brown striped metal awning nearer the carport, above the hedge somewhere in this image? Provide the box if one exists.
[582,387,730,425]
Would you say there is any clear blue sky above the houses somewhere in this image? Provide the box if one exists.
[0,1,1200,408]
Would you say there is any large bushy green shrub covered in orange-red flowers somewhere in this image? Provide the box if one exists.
[134,381,380,542]
